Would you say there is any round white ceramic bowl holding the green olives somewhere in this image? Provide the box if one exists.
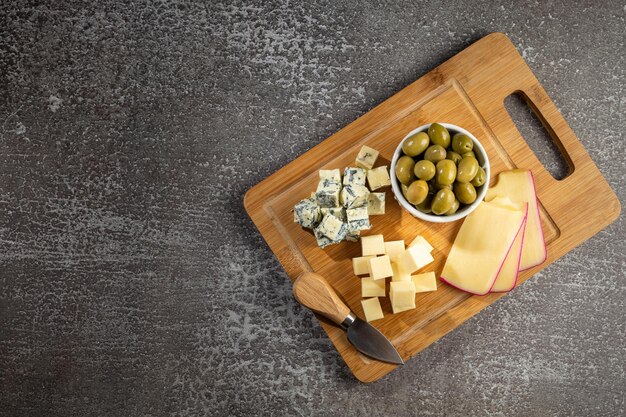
[389,123,491,223]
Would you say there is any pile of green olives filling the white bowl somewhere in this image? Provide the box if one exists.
[395,123,486,216]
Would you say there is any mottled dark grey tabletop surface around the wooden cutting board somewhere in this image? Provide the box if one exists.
[0,0,626,416]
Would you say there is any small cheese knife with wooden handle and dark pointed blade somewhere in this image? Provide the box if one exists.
[293,272,404,365]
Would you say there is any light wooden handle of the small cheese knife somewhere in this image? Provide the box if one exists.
[293,272,350,324]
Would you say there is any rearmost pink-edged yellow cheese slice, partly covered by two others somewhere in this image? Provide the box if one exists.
[485,169,547,271]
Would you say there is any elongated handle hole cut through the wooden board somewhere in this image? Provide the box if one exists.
[504,92,572,180]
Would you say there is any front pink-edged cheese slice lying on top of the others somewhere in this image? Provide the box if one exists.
[441,199,528,295]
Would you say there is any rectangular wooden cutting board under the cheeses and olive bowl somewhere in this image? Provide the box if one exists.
[244,33,620,382]
